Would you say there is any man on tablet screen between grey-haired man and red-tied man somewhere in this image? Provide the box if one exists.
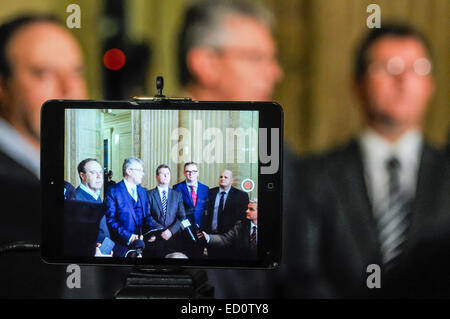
[148,164,186,257]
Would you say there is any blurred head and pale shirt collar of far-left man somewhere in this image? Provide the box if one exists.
[0,17,87,178]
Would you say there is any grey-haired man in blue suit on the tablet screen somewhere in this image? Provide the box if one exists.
[105,157,152,257]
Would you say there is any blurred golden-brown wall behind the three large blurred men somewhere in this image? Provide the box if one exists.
[0,0,450,154]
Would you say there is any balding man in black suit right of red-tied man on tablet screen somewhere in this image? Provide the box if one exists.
[203,170,249,258]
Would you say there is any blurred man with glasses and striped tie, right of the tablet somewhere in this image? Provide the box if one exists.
[285,25,450,298]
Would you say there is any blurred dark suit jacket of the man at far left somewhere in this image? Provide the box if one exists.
[0,150,129,298]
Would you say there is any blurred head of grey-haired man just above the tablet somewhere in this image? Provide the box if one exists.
[178,1,283,101]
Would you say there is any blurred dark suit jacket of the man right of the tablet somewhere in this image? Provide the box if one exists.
[283,140,450,298]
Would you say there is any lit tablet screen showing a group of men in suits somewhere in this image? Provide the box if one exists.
[65,109,259,260]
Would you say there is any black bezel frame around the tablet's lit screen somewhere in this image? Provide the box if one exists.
[41,99,283,268]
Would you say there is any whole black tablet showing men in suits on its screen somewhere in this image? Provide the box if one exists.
[41,98,283,268]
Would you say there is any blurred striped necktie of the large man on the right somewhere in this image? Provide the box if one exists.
[377,157,411,269]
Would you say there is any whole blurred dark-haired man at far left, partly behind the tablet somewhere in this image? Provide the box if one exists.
[0,16,128,298]
